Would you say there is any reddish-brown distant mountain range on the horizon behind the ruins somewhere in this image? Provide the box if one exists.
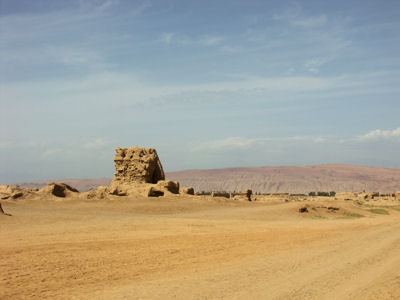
[13,164,400,193]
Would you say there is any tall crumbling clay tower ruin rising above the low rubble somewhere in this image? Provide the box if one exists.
[111,146,165,185]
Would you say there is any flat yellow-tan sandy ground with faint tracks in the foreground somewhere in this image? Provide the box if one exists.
[0,196,400,299]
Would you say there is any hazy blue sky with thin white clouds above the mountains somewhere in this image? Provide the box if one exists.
[0,0,400,183]
